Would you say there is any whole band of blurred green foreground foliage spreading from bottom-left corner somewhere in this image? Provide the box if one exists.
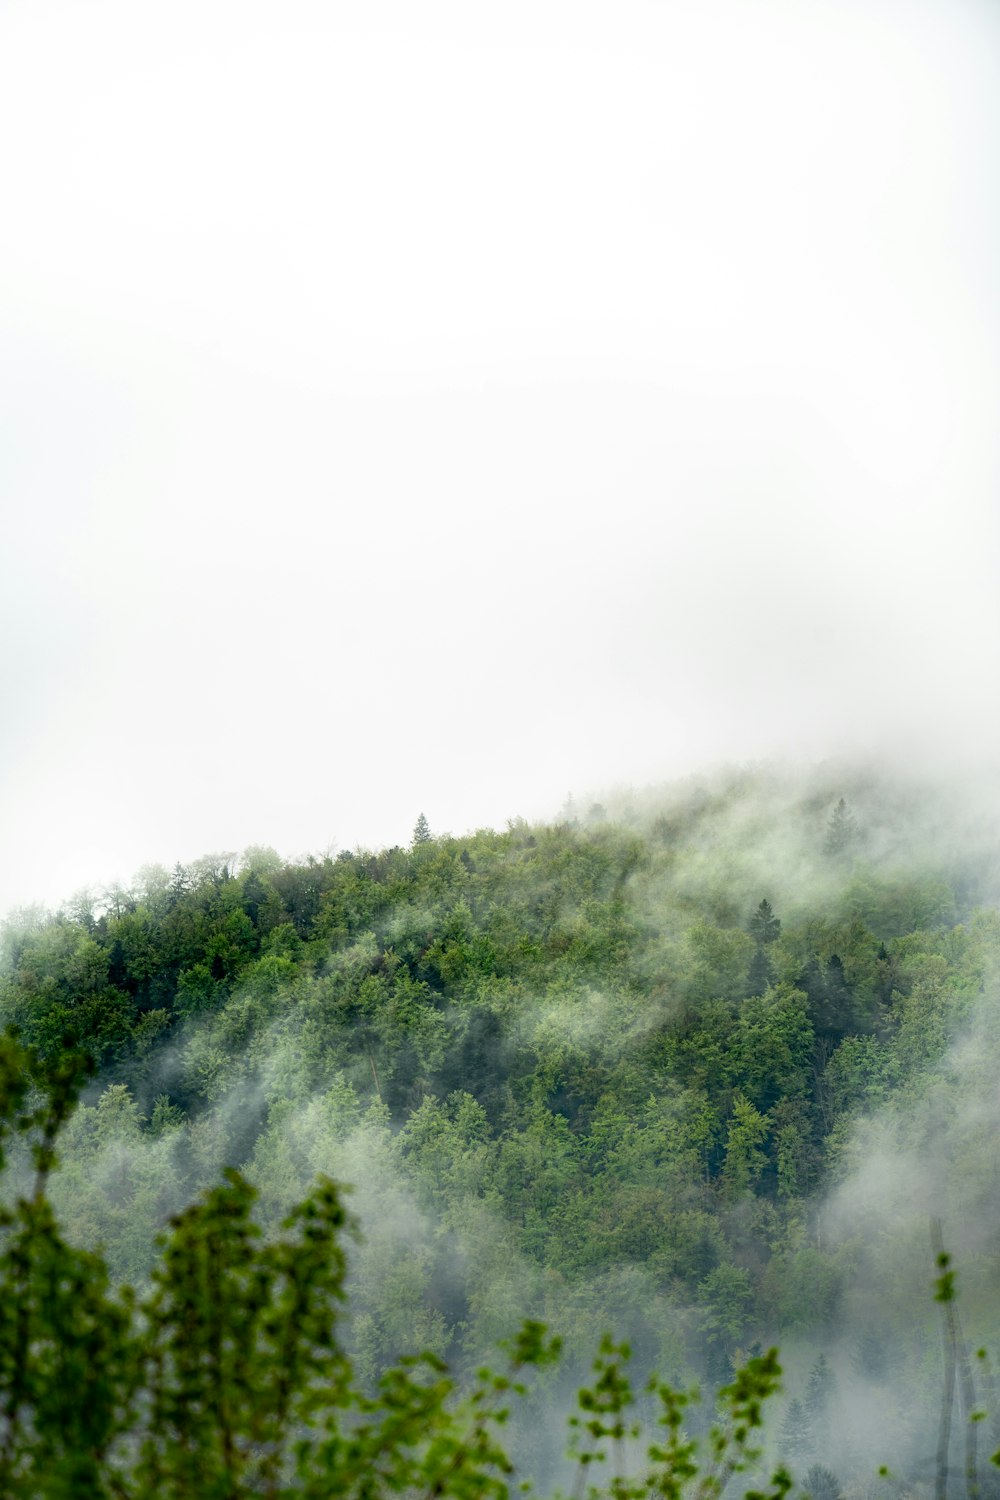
[0,1037,790,1500]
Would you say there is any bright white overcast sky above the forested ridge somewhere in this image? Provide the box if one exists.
[0,0,1000,911]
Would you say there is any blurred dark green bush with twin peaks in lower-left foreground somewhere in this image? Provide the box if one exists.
[136,1172,351,1497]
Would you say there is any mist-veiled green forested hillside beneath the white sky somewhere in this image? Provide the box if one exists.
[0,767,1000,1500]
